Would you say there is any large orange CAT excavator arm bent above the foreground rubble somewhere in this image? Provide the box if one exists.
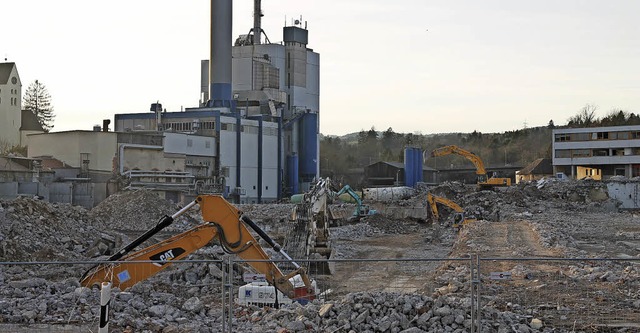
[81,195,315,302]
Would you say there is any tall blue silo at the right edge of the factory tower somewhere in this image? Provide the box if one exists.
[298,113,318,179]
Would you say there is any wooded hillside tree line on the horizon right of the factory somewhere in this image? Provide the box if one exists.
[320,104,640,187]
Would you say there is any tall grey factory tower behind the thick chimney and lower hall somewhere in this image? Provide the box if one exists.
[200,9,320,194]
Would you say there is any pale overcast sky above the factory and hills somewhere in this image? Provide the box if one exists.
[0,0,640,135]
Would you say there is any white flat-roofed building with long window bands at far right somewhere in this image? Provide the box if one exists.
[553,125,640,180]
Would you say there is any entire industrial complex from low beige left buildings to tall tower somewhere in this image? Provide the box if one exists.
[13,0,320,203]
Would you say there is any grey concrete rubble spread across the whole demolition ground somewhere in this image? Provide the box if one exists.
[0,180,640,333]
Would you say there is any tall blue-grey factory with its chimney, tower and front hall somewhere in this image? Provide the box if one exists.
[115,0,320,203]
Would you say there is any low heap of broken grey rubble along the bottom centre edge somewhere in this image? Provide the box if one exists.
[238,292,557,333]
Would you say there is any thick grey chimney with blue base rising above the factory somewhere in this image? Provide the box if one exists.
[209,0,232,107]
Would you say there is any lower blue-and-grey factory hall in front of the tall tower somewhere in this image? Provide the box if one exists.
[115,104,282,203]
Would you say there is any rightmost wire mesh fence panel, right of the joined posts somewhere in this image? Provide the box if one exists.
[480,258,640,332]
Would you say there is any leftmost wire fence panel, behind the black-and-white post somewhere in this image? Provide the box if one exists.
[0,260,225,333]
